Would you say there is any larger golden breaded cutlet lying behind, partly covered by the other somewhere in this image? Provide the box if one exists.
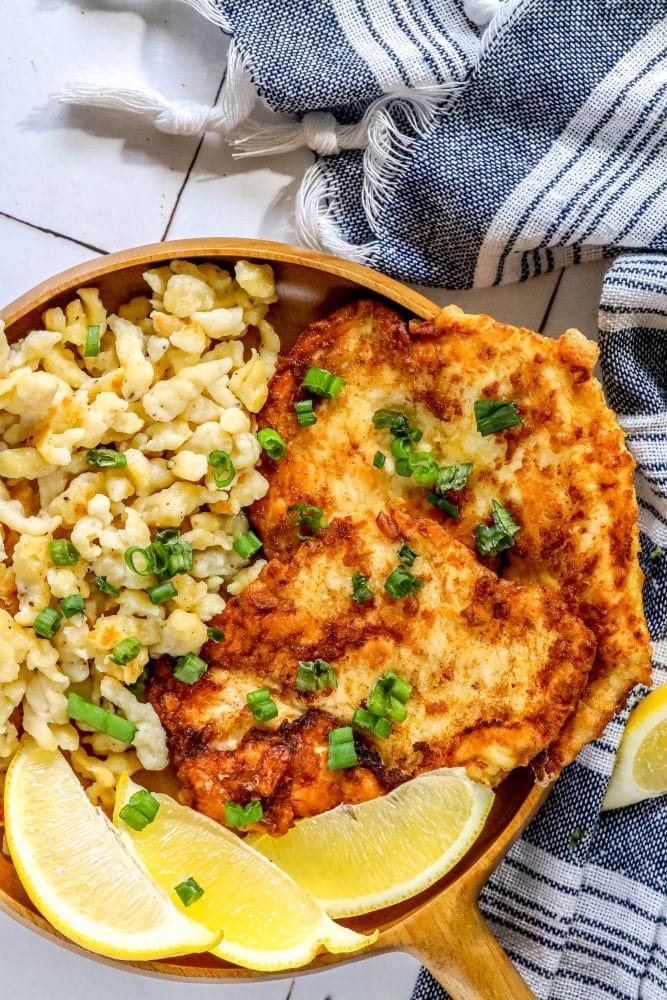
[252,301,650,777]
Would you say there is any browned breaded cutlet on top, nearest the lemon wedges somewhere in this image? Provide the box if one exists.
[149,510,595,834]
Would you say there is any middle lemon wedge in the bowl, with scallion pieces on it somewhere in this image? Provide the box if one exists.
[114,775,377,972]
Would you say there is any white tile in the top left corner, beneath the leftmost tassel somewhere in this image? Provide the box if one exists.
[0,0,227,250]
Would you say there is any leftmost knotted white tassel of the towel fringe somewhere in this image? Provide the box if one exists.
[58,39,257,135]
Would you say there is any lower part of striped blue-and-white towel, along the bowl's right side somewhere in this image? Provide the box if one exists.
[413,255,667,1000]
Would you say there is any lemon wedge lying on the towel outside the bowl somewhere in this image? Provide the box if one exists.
[602,684,667,810]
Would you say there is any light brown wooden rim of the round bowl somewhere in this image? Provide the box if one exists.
[0,237,546,984]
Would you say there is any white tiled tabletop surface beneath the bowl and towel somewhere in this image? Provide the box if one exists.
[0,0,604,1000]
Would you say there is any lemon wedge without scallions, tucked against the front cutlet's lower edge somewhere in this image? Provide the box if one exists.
[248,768,494,917]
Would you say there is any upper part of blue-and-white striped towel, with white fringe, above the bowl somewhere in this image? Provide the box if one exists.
[62,0,667,288]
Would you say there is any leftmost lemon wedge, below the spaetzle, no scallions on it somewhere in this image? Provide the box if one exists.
[4,740,220,960]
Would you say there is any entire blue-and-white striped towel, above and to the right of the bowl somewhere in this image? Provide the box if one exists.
[63,0,667,1000]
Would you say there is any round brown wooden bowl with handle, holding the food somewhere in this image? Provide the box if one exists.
[0,239,546,1000]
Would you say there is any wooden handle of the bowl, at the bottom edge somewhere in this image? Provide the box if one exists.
[383,891,536,1000]
